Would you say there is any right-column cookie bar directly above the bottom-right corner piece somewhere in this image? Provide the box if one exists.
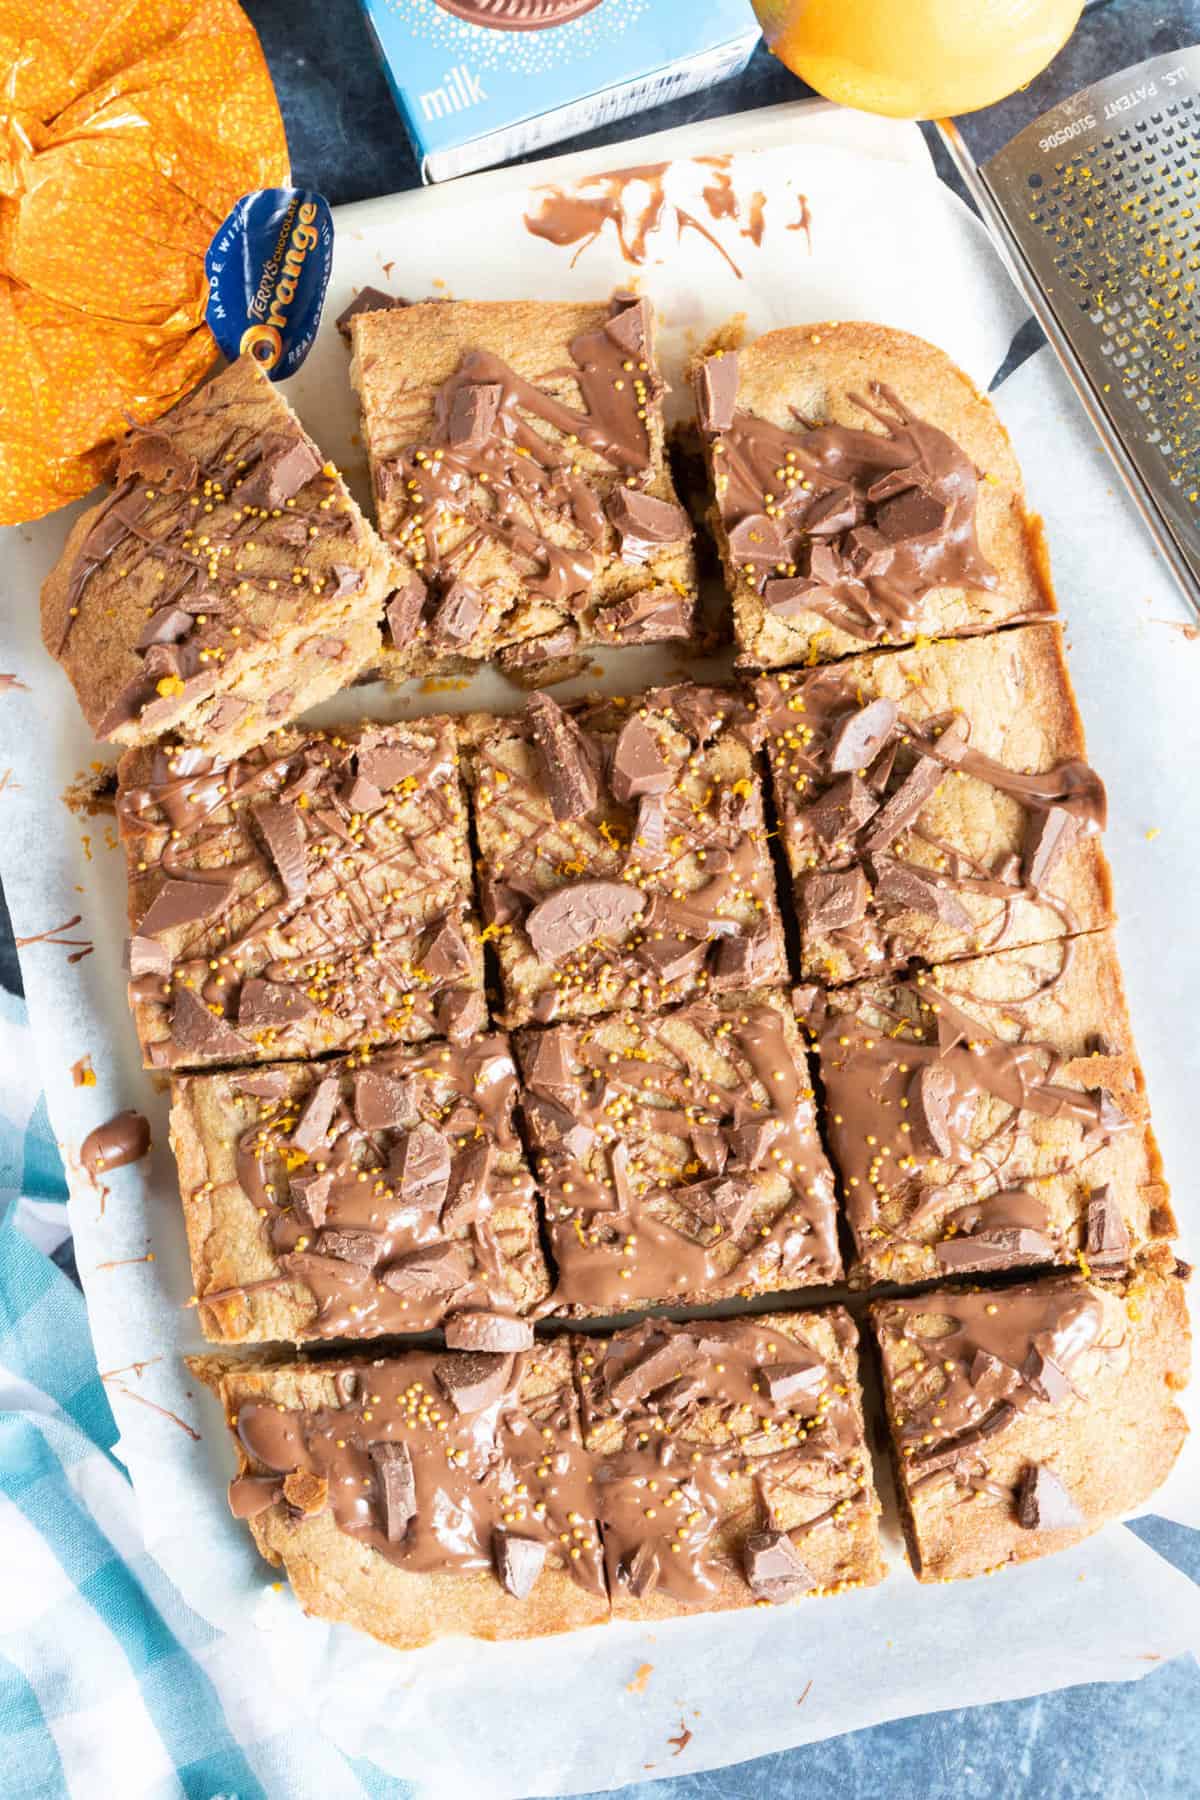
[813,931,1175,1283]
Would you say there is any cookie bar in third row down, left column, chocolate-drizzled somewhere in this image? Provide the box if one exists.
[171,1037,551,1350]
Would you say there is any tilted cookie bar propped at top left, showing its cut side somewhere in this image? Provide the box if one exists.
[41,356,403,756]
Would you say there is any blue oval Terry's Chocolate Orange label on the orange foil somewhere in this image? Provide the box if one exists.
[203,187,333,382]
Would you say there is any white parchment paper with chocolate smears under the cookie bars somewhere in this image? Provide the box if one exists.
[0,106,1200,1796]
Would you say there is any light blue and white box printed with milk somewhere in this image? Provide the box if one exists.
[362,0,759,182]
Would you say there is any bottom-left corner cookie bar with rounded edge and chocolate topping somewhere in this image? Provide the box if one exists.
[201,1343,608,1649]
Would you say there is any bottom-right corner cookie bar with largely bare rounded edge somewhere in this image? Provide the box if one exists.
[871,1246,1191,1580]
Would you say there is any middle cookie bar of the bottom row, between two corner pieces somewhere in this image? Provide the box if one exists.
[576,1307,885,1618]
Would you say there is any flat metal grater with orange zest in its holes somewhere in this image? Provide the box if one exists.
[939,47,1200,614]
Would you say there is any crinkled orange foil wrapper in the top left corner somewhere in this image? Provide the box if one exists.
[0,0,288,524]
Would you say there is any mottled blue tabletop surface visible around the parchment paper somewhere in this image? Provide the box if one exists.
[0,0,1200,1800]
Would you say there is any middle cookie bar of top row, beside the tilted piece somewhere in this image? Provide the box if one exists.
[349,293,696,686]
